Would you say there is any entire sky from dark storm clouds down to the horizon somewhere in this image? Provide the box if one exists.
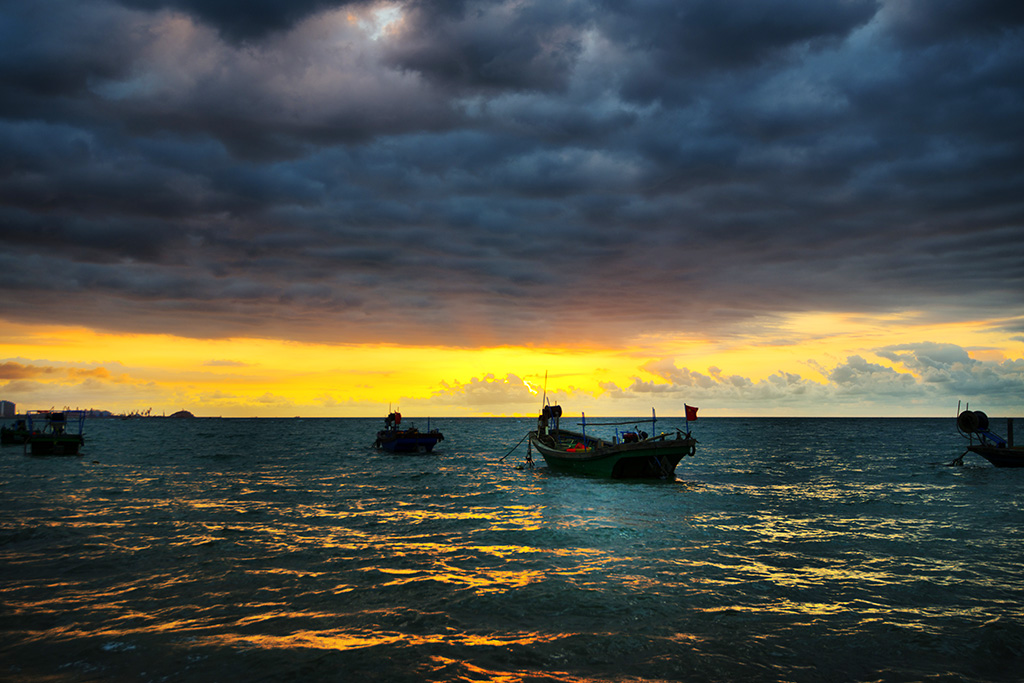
[0,0,1024,417]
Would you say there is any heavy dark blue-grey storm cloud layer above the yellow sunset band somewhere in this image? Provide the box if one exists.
[0,0,1024,348]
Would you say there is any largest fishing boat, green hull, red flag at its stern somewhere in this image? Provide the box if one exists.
[527,405,697,479]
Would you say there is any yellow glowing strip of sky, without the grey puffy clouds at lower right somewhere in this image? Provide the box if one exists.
[0,313,1022,417]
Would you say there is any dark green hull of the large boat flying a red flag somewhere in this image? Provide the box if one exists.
[529,430,696,479]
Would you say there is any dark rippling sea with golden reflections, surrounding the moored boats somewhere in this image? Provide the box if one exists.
[0,418,1024,682]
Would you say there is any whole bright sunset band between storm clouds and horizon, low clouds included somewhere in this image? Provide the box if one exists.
[0,315,1022,417]
